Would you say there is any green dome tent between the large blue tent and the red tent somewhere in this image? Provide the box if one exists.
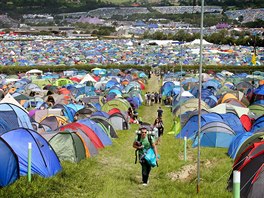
[48,131,86,163]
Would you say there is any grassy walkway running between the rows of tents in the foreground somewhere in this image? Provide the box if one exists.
[0,76,232,198]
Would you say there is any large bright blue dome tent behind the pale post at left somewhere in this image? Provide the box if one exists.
[1,128,62,177]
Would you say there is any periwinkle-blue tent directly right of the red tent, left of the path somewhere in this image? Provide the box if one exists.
[78,119,112,146]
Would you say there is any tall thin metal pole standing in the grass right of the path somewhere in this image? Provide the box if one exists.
[197,0,204,193]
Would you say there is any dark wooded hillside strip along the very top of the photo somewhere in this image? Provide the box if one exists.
[0,0,263,16]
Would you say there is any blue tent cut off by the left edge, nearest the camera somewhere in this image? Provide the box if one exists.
[0,138,19,187]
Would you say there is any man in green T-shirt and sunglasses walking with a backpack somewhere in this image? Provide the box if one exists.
[133,127,158,186]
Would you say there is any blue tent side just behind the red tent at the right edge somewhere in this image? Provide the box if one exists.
[228,132,253,159]
